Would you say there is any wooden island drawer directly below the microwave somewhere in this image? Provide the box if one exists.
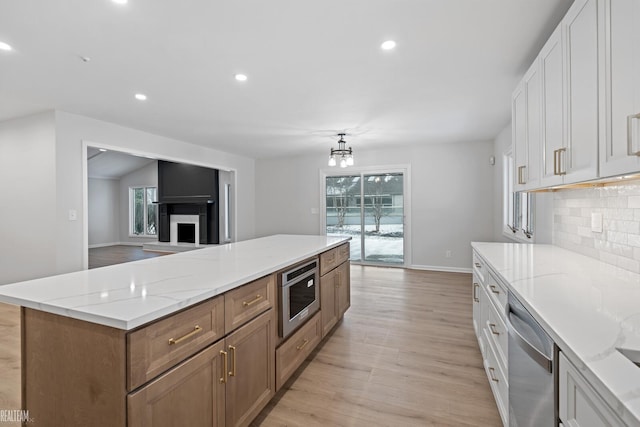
[276,312,322,390]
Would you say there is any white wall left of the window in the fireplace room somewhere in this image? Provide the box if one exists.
[88,178,120,247]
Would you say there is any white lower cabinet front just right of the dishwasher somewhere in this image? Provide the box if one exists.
[558,352,625,427]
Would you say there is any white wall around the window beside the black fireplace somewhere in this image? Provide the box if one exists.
[118,161,158,246]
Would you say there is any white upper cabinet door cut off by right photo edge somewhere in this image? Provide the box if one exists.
[600,0,640,177]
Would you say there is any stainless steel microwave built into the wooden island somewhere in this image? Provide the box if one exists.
[278,258,320,338]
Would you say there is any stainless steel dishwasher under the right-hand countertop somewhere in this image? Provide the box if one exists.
[506,292,558,427]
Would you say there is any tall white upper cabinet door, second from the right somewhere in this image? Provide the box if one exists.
[560,0,598,184]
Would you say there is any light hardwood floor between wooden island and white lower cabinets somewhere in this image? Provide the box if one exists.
[253,266,502,427]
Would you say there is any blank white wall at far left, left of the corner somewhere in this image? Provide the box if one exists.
[0,112,56,284]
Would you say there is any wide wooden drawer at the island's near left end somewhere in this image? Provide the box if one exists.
[127,296,224,390]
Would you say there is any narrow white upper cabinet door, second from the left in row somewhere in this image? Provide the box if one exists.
[524,60,542,190]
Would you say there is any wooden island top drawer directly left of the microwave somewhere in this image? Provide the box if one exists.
[224,274,276,333]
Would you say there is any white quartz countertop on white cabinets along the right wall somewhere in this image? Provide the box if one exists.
[472,243,640,426]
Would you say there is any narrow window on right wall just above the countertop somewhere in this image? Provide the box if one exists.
[502,151,534,241]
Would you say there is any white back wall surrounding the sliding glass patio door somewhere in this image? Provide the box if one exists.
[256,141,494,271]
